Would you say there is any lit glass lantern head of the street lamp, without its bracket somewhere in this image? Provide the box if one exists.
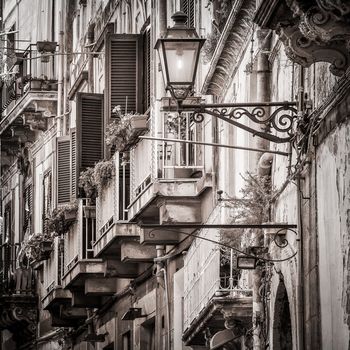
[155,11,205,101]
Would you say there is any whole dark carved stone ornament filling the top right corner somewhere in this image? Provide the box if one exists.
[254,0,350,76]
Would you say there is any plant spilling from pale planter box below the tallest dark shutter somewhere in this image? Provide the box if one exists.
[106,106,147,152]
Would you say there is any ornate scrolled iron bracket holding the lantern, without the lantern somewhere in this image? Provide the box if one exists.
[178,101,298,143]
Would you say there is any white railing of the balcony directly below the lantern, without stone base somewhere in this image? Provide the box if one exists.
[130,112,204,201]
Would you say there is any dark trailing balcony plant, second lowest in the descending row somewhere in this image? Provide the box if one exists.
[48,203,78,235]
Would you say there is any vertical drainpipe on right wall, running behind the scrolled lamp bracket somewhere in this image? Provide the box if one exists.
[252,30,273,350]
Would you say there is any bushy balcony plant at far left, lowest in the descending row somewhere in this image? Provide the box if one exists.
[22,233,54,262]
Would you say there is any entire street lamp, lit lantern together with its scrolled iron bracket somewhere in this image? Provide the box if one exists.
[155,12,304,143]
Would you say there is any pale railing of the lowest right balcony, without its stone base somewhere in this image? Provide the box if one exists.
[184,233,252,329]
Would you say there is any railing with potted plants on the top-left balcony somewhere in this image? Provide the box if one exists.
[1,44,58,113]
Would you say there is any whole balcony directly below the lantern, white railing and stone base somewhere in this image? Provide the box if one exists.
[127,108,211,223]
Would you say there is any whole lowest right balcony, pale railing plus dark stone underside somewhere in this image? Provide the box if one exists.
[183,238,253,346]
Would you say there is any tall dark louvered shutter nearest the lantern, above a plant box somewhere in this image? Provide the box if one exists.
[105,34,143,119]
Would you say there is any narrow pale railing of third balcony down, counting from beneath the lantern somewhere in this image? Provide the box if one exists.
[63,198,96,274]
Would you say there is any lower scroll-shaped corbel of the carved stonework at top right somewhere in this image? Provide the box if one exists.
[277,25,350,76]
